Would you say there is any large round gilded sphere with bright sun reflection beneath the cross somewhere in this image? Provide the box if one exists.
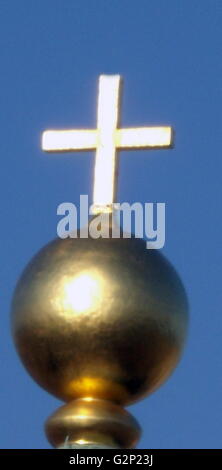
[12,226,188,404]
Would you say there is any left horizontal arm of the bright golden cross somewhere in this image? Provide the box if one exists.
[42,129,98,152]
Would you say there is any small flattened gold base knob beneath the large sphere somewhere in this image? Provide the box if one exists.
[45,398,141,448]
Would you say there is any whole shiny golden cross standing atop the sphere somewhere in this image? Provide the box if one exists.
[42,75,172,213]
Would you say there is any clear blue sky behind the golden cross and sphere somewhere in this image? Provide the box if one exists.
[0,0,222,448]
